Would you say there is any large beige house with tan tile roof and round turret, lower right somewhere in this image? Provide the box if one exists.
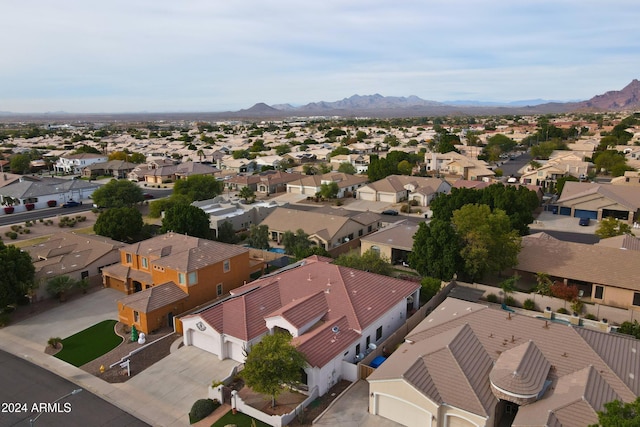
[367,298,640,427]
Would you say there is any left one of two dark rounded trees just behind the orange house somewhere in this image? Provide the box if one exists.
[93,207,144,242]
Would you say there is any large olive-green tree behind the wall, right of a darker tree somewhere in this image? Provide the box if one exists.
[452,204,521,279]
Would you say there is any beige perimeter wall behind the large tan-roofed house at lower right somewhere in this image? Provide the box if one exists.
[458,282,640,324]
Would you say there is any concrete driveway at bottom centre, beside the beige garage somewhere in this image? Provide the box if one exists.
[313,380,402,427]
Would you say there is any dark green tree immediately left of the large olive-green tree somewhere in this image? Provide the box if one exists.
[409,219,464,280]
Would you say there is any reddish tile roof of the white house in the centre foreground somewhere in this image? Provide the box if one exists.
[192,257,420,366]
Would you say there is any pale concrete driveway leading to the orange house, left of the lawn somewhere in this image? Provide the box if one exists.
[4,288,124,349]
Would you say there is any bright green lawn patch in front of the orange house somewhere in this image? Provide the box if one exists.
[55,320,122,366]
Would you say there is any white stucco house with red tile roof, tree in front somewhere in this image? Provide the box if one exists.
[181,256,420,395]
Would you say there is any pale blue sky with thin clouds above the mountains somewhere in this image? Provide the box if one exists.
[0,0,640,113]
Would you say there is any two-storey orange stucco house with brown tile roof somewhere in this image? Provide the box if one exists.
[102,233,259,334]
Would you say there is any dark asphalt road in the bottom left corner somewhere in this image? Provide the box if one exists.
[0,351,148,427]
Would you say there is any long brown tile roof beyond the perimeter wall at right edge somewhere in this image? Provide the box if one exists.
[516,235,640,290]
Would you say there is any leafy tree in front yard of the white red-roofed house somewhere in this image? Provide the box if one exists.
[240,332,307,407]
